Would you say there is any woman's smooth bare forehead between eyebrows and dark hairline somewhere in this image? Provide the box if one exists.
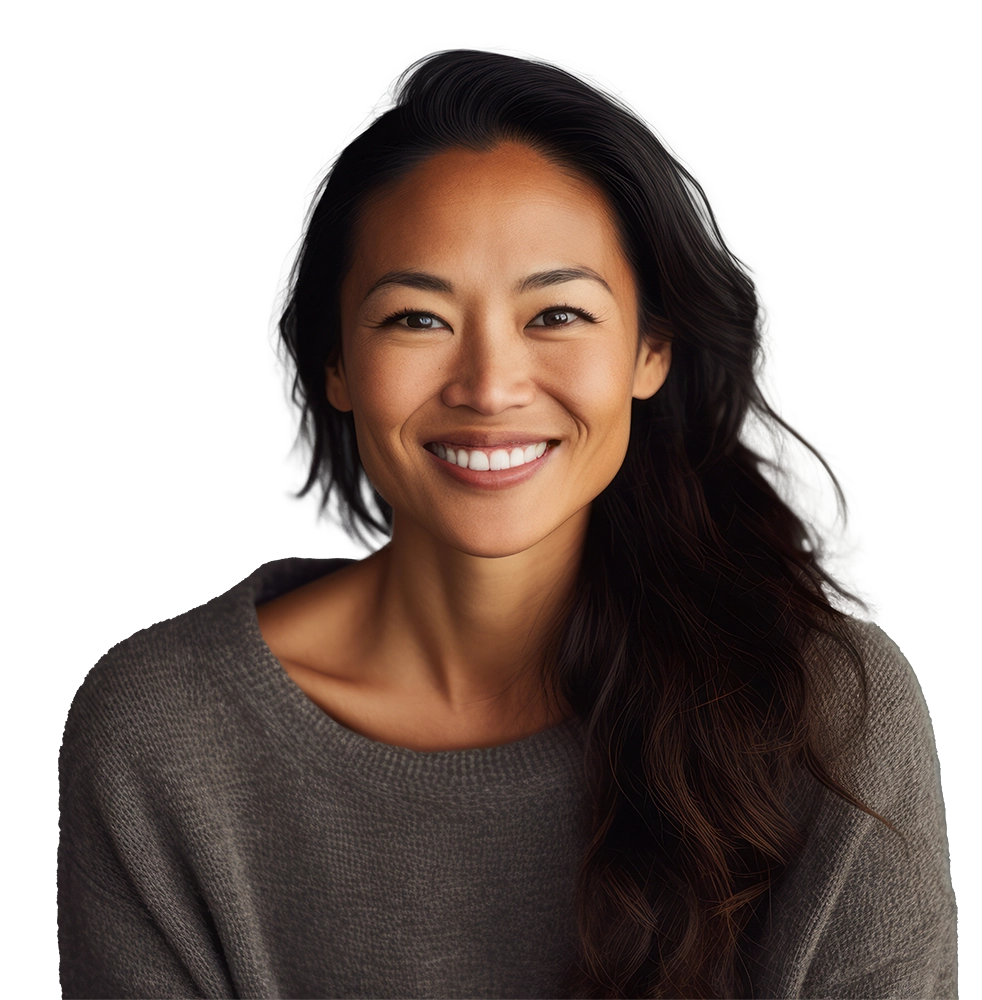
[354,142,636,278]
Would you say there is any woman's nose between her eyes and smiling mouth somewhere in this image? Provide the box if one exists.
[442,322,535,416]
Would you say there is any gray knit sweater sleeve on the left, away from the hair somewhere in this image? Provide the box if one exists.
[57,657,234,1000]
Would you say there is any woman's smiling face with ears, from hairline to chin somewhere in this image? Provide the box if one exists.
[327,143,670,557]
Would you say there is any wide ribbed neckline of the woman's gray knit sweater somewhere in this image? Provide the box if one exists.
[226,558,584,789]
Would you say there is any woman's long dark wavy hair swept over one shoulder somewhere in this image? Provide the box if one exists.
[279,49,889,1000]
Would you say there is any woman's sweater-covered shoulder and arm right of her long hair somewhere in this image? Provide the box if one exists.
[763,608,955,996]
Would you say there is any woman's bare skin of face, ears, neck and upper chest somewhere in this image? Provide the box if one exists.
[258,143,671,750]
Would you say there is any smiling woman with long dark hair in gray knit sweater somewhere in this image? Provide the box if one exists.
[59,50,956,1000]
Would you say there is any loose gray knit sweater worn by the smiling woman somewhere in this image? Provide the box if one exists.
[58,559,956,1000]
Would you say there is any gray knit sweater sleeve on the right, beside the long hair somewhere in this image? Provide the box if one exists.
[789,622,957,1000]
